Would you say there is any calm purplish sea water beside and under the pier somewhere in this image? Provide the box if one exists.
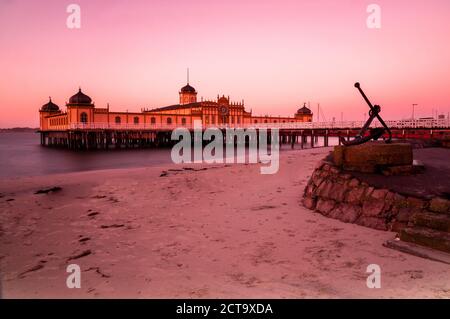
[0,133,337,177]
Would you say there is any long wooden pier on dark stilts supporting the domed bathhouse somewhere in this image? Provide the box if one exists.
[39,120,450,150]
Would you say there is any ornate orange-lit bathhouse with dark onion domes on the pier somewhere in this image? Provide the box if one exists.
[39,83,313,131]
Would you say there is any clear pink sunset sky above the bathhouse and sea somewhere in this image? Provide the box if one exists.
[0,0,450,127]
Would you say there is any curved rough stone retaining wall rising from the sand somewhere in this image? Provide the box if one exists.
[303,160,450,232]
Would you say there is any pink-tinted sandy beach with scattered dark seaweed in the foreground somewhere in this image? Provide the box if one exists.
[0,148,450,298]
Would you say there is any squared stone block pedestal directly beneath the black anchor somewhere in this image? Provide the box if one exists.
[333,142,413,173]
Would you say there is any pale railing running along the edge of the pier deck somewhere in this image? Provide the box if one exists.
[49,119,450,130]
